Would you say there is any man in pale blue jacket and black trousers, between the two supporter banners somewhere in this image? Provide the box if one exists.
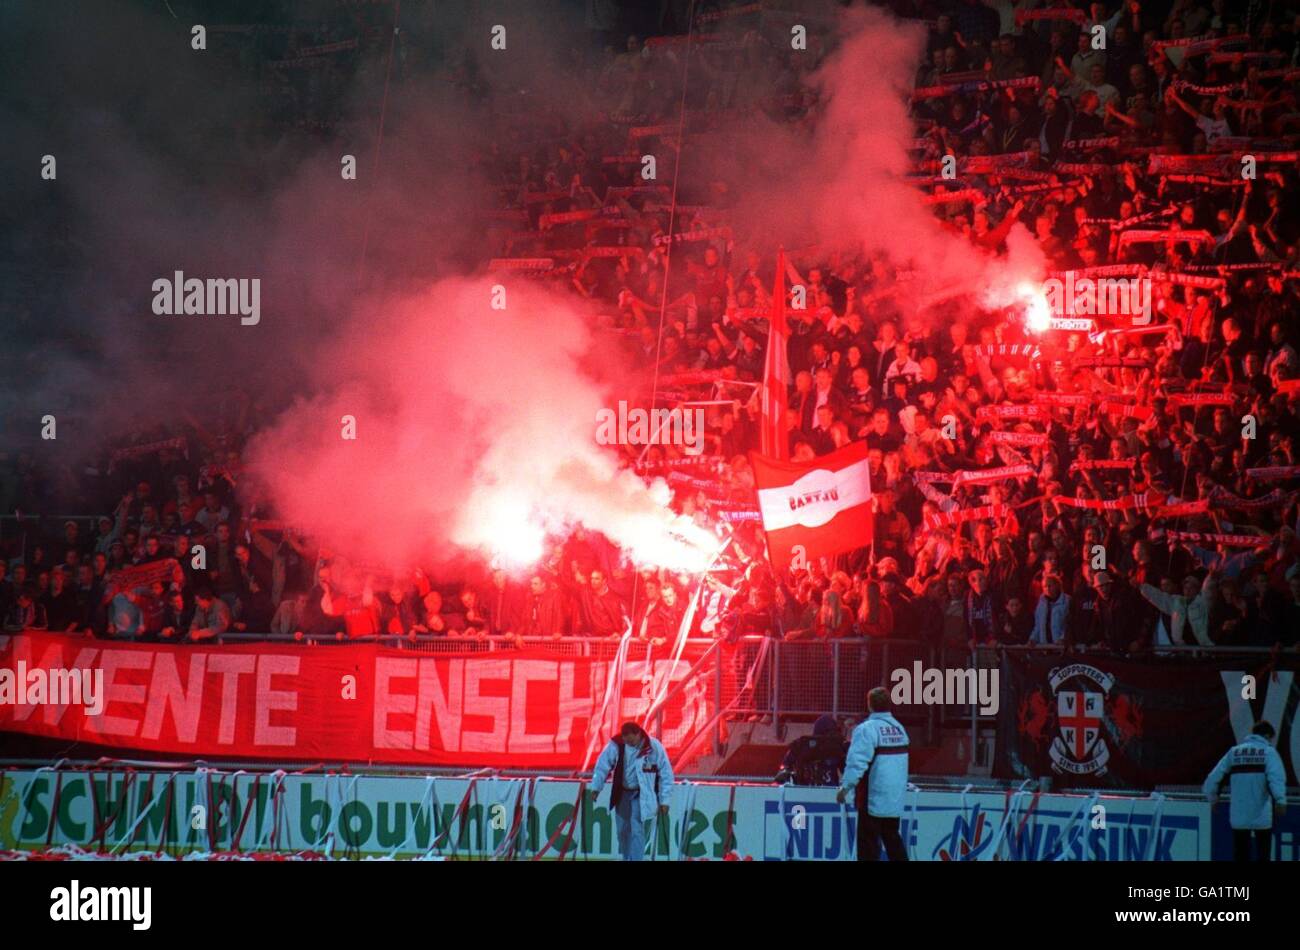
[836,686,907,860]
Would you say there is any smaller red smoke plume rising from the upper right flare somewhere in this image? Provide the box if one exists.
[684,8,1043,307]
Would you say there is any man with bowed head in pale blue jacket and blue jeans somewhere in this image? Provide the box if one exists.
[592,723,672,860]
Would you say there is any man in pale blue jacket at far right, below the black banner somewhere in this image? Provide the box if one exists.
[1201,720,1287,860]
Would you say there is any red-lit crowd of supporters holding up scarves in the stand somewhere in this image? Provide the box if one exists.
[0,0,1300,654]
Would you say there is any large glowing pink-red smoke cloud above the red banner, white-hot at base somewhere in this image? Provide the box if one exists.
[241,278,712,569]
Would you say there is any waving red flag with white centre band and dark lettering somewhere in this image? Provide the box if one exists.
[750,442,872,569]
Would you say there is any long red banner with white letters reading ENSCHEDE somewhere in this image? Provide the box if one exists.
[0,632,712,768]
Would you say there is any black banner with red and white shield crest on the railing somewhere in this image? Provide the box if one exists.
[993,651,1300,789]
